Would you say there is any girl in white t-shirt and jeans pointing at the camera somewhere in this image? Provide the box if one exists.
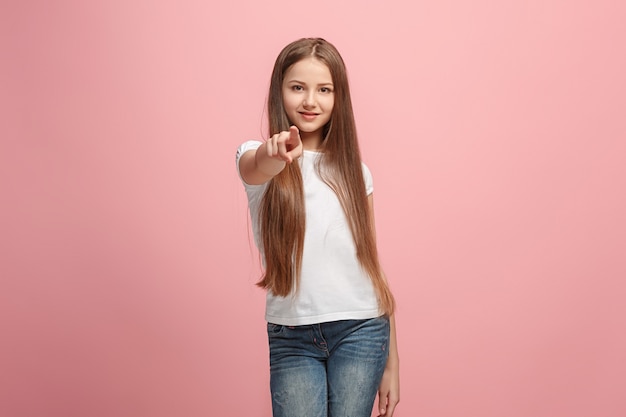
[237,39,399,417]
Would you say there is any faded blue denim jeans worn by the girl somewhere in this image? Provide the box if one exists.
[267,316,389,417]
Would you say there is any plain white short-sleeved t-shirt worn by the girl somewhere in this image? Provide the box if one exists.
[237,141,380,326]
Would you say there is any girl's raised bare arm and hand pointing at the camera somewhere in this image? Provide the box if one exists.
[239,126,302,185]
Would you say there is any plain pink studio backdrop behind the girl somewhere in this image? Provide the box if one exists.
[0,0,626,417]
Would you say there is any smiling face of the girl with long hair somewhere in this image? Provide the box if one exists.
[283,57,335,145]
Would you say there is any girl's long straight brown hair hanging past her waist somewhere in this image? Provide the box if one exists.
[258,38,395,314]
